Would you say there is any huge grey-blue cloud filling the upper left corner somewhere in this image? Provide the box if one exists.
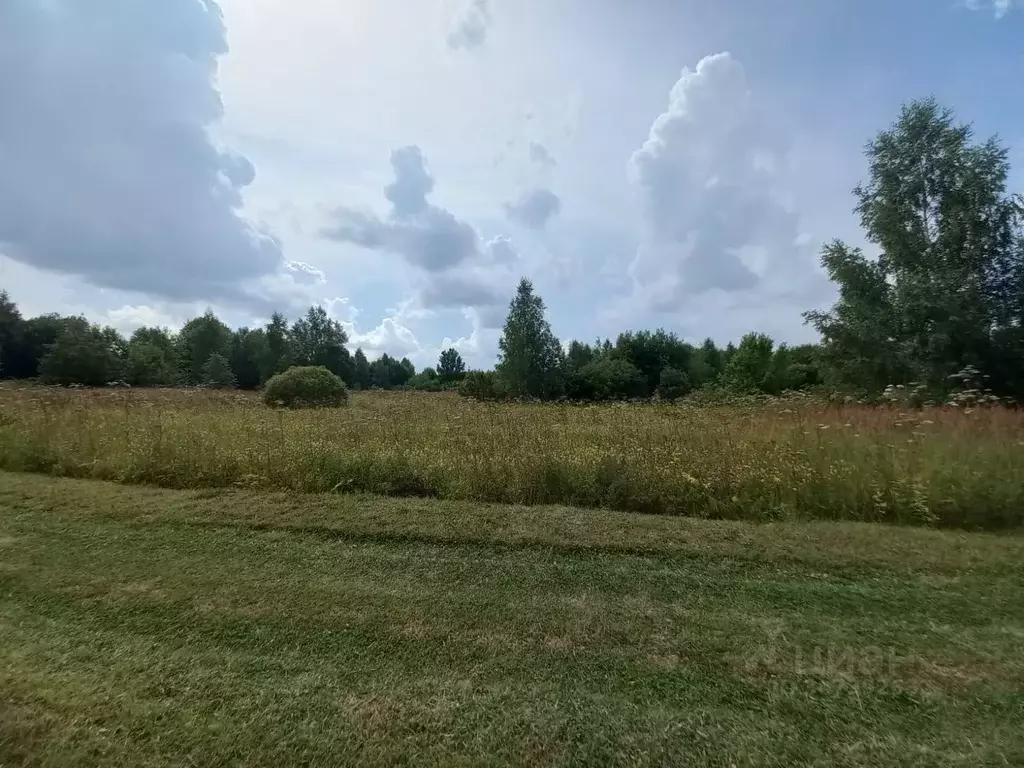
[0,0,282,307]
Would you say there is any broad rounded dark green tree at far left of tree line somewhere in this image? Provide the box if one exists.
[39,317,122,387]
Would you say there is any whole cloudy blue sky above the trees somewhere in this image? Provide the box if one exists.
[0,0,1024,367]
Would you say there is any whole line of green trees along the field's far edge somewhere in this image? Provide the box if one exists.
[0,99,1024,400]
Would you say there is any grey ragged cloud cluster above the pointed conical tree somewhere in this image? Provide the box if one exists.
[321,146,518,315]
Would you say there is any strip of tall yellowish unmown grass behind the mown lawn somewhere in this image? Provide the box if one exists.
[0,388,1024,529]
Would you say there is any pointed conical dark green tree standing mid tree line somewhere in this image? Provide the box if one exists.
[496,279,562,398]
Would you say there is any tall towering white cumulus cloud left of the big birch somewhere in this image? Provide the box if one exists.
[629,53,807,308]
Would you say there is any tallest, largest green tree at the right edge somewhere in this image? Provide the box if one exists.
[805,99,1024,391]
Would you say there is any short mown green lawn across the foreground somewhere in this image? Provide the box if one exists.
[0,473,1024,766]
